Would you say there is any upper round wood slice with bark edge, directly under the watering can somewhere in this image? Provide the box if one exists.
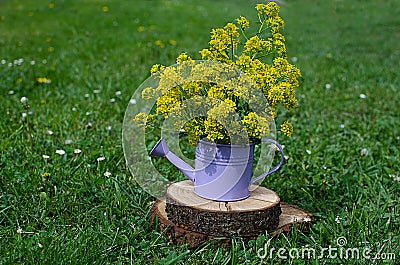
[165,180,282,237]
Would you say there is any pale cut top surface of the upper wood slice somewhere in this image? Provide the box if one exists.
[167,180,280,212]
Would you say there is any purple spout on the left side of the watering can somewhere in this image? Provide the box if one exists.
[149,138,195,182]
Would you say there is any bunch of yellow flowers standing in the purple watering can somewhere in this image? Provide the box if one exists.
[135,2,301,146]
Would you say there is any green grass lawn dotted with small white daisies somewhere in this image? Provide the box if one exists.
[0,0,400,264]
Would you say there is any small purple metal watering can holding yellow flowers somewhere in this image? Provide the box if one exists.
[149,138,284,201]
